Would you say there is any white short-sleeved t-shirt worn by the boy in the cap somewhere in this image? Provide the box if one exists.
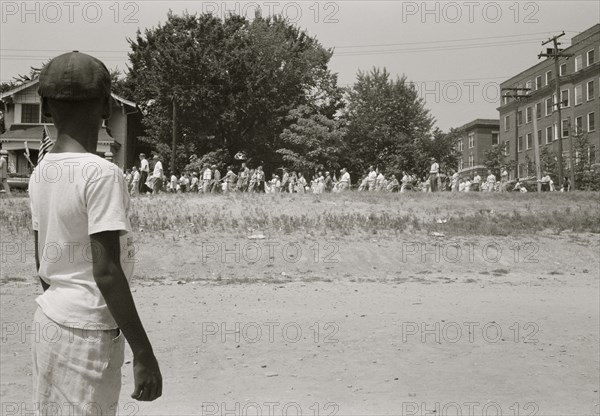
[29,153,135,330]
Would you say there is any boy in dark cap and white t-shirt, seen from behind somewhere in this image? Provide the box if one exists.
[29,52,162,415]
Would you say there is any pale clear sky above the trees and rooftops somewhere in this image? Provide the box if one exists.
[0,0,600,131]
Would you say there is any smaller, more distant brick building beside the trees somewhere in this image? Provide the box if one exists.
[456,118,500,176]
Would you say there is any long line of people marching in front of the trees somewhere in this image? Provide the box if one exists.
[124,153,554,195]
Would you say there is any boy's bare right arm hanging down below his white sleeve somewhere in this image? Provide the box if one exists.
[90,231,162,401]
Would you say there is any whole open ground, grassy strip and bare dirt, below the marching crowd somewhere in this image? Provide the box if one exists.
[0,193,600,415]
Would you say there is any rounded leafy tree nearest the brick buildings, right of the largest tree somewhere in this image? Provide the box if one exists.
[345,68,434,174]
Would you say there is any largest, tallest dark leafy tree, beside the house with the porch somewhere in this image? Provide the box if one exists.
[129,12,331,174]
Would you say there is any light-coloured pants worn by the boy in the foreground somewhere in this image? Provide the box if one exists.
[32,307,125,416]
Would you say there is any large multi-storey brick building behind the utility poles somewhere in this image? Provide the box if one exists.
[498,24,600,178]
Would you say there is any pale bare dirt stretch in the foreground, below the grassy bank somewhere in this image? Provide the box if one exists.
[1,264,599,415]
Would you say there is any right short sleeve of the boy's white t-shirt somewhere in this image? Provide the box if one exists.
[85,165,131,235]
